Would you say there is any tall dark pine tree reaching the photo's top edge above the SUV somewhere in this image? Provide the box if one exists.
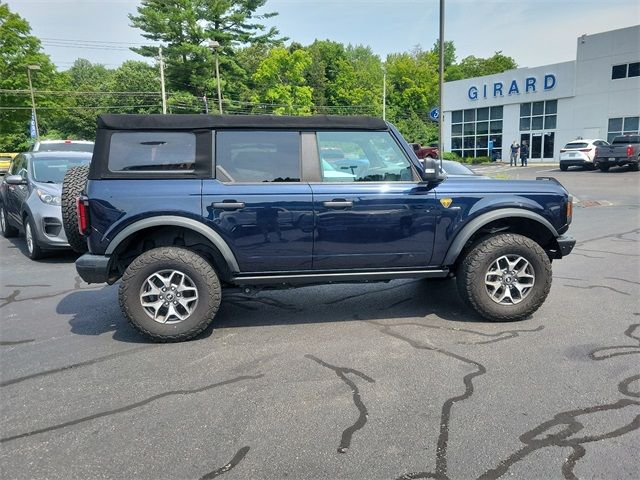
[129,0,280,96]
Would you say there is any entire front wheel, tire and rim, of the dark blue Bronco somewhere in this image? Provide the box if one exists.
[457,233,551,322]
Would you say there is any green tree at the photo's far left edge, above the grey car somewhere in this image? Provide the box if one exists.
[0,3,66,151]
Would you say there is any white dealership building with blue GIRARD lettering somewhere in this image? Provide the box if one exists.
[443,25,640,162]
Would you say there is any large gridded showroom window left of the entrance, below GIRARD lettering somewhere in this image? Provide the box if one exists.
[451,107,503,157]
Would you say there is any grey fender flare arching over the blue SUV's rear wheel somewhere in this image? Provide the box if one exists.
[105,215,240,273]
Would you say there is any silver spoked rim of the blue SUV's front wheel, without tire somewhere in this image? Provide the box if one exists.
[484,255,536,305]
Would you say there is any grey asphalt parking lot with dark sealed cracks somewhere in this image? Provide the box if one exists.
[0,165,640,479]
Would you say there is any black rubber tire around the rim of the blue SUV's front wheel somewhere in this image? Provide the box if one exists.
[456,233,552,322]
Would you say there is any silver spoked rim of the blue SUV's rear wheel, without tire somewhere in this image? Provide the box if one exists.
[140,270,198,324]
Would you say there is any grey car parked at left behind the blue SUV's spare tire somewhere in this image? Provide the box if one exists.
[0,152,91,259]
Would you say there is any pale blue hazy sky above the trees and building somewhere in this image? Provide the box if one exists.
[4,0,640,69]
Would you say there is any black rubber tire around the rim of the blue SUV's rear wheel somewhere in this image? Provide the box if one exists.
[118,247,222,342]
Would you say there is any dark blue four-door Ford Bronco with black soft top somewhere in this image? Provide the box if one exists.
[62,115,575,341]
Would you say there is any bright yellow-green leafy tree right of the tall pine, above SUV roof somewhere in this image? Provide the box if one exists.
[253,48,313,115]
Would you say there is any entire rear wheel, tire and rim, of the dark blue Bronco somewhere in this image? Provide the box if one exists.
[118,247,222,342]
